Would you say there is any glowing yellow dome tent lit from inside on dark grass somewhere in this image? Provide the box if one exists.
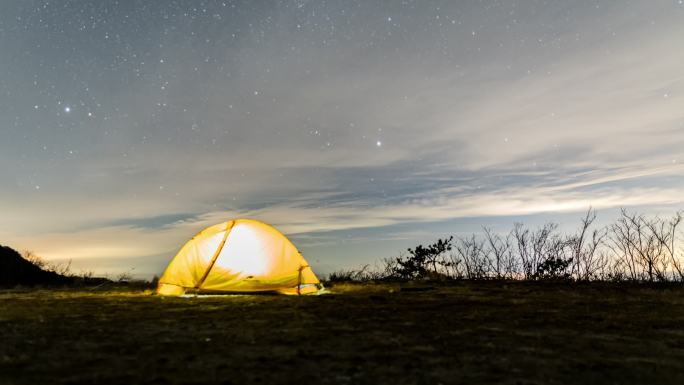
[157,219,322,295]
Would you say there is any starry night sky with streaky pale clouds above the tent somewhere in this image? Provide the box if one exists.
[0,0,684,276]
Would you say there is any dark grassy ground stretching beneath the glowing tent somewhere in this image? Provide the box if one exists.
[0,282,684,385]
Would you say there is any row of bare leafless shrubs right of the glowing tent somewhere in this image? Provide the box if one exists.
[329,209,684,282]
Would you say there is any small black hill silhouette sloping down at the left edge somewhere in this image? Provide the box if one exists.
[0,245,73,287]
